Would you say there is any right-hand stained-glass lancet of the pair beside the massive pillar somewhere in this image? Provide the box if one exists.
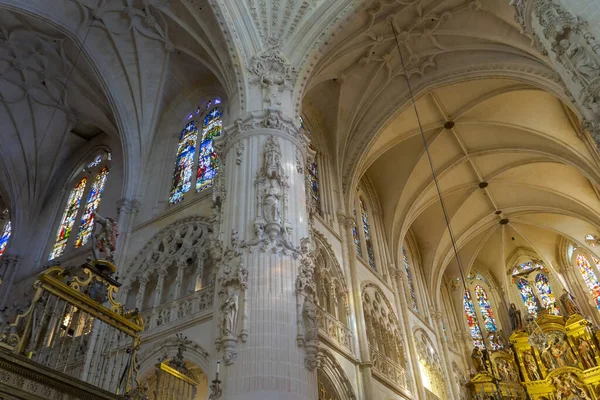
[196,107,223,191]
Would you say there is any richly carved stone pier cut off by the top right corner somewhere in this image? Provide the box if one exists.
[510,0,600,146]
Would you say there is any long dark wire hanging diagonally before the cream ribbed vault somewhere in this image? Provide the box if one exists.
[390,21,492,344]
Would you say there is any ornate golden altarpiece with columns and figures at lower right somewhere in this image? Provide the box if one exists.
[467,314,600,400]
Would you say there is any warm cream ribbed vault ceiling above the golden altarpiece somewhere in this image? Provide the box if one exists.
[366,79,600,288]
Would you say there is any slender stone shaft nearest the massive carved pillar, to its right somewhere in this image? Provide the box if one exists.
[337,213,374,399]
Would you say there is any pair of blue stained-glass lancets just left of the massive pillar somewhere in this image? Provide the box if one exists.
[169,99,223,204]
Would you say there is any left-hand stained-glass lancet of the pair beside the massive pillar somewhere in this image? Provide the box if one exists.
[169,121,198,204]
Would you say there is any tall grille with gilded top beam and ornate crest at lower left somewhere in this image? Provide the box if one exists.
[0,260,144,395]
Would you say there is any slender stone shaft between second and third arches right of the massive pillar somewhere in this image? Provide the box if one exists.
[390,266,426,399]
